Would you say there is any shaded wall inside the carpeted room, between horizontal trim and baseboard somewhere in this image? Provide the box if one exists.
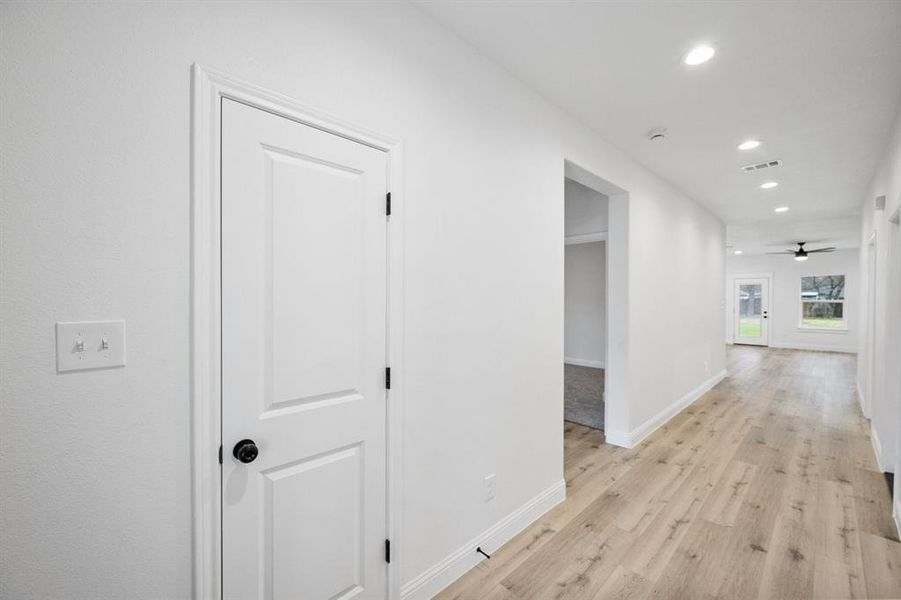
[563,242,607,368]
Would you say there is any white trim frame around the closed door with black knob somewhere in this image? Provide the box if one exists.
[191,64,404,600]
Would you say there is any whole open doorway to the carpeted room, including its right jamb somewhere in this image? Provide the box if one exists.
[560,160,635,448]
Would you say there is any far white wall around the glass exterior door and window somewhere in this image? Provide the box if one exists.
[725,245,862,352]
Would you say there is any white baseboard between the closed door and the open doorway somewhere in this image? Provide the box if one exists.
[400,479,566,600]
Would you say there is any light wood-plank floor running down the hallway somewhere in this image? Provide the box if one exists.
[438,346,901,600]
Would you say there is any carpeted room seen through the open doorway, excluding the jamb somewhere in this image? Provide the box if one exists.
[563,179,608,430]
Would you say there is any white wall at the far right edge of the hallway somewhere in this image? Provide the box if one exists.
[857,106,901,482]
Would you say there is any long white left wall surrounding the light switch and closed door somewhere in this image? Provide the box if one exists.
[0,2,725,599]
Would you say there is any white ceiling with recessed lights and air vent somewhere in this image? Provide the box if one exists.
[420,0,901,249]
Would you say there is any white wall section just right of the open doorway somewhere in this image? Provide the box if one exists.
[624,180,726,432]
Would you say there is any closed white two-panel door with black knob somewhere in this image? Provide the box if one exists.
[221,99,388,600]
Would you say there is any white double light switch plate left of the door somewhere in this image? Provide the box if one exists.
[56,321,125,373]
